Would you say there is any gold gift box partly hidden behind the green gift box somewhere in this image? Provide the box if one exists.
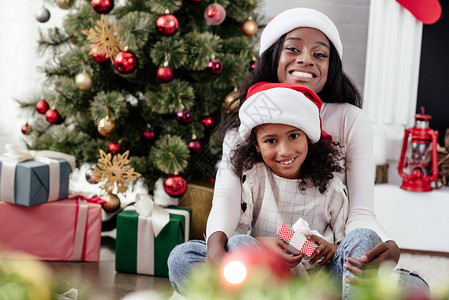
[179,181,214,240]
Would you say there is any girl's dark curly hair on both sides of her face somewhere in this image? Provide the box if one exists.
[230,127,344,194]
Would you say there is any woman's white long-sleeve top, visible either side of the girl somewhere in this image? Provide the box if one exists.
[206,103,390,241]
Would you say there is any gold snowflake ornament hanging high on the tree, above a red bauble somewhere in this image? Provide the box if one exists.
[81,15,123,62]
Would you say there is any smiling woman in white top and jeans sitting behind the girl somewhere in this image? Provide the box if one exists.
[169,8,426,298]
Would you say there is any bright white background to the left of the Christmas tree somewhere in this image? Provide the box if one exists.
[0,0,64,153]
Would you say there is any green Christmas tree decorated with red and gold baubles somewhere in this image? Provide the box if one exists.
[19,0,260,196]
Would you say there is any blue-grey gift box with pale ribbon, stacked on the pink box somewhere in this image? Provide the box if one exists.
[0,145,75,206]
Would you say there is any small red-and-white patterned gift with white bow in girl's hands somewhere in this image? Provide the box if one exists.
[276,218,321,257]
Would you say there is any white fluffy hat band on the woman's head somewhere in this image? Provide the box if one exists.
[259,7,343,59]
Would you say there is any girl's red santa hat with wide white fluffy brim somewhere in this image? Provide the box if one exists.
[239,82,332,143]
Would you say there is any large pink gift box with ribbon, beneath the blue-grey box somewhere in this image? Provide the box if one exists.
[0,199,101,261]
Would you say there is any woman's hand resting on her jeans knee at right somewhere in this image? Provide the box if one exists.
[344,240,400,283]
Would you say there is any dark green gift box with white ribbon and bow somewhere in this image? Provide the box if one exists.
[115,195,192,277]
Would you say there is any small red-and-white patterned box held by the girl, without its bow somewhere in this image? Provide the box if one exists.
[276,224,318,257]
